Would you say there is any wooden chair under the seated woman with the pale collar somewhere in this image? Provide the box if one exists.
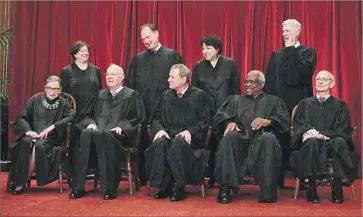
[6,92,76,194]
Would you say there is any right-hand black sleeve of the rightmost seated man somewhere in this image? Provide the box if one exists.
[320,102,354,148]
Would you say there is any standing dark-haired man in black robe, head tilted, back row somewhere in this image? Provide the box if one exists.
[126,23,183,184]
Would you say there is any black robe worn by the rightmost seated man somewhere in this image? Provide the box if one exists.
[290,96,359,180]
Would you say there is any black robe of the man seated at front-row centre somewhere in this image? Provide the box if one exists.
[145,85,211,188]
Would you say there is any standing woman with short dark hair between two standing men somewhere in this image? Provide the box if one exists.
[192,35,241,187]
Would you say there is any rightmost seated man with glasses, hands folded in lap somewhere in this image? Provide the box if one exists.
[290,71,359,203]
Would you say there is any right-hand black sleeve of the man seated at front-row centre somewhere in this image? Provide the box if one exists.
[187,92,211,136]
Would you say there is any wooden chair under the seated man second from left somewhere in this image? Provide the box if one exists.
[88,124,142,196]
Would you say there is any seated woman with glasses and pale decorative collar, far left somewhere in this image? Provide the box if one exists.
[10,76,74,194]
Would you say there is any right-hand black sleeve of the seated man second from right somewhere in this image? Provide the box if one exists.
[266,98,290,134]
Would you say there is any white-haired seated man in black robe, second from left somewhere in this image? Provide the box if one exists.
[69,64,145,200]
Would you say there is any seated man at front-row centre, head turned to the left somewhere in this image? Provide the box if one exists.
[145,64,211,201]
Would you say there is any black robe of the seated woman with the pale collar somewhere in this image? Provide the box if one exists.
[10,94,74,186]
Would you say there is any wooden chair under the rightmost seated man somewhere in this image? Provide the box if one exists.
[290,105,357,200]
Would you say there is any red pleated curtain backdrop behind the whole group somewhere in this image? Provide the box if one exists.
[10,1,362,164]
